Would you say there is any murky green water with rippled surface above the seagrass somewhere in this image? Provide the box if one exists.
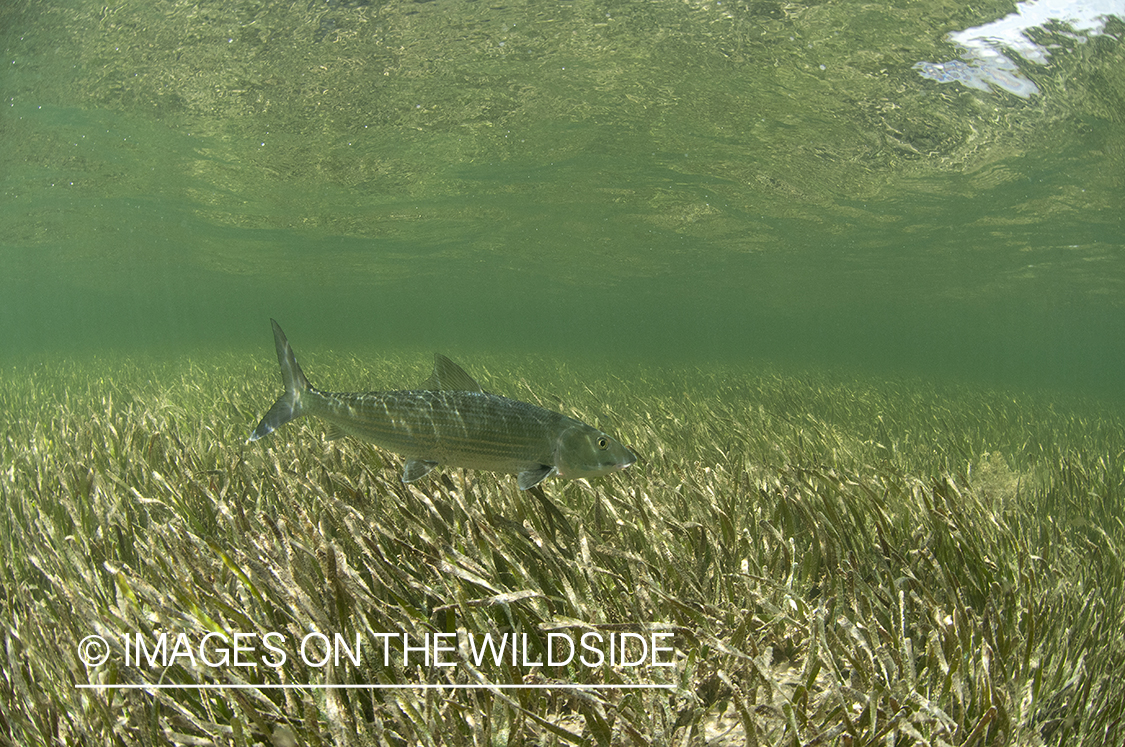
[0,0,1125,396]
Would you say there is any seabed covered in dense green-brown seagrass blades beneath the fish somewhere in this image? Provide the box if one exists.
[0,354,1125,745]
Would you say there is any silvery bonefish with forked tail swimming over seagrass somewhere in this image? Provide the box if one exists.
[250,320,637,491]
